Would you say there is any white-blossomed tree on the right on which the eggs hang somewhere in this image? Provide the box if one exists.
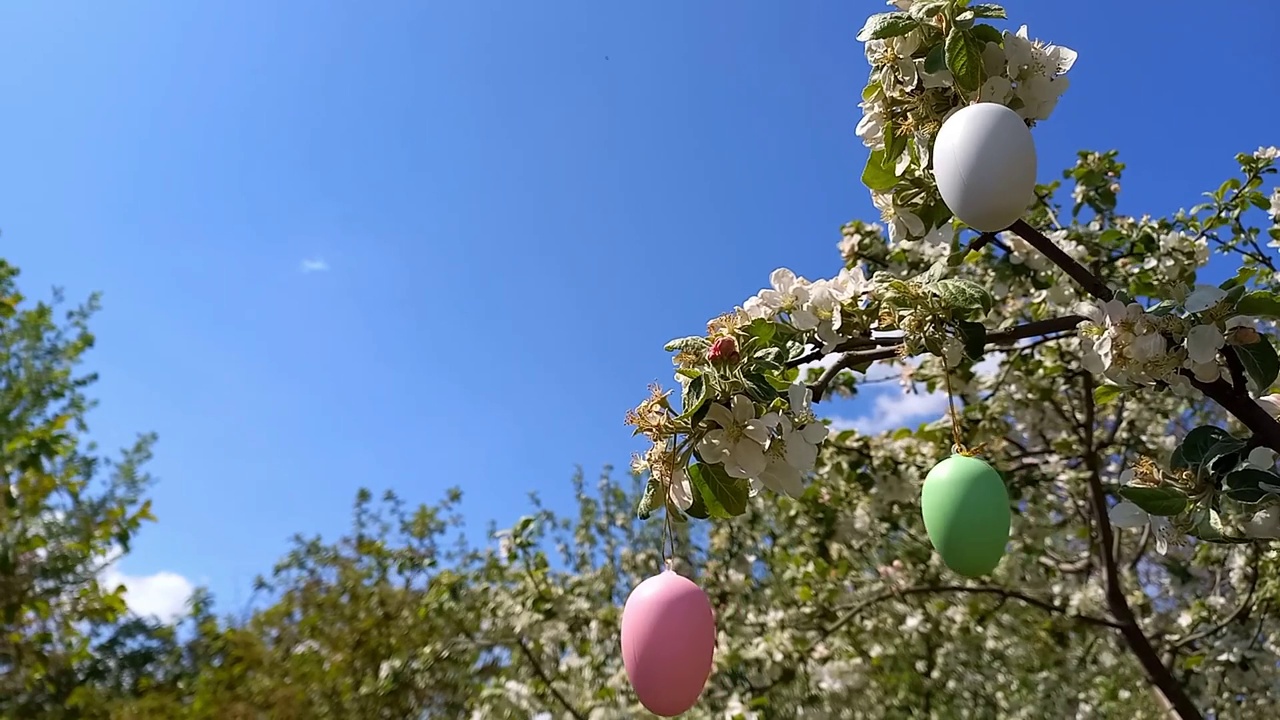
[627,0,1280,717]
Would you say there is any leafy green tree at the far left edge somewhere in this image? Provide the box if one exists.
[0,254,163,717]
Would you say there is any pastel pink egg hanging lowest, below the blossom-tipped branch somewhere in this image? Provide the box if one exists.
[622,570,716,717]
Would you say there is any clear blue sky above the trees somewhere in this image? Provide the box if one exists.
[0,0,1280,617]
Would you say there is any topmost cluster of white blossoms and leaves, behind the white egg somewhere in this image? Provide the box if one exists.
[856,0,1076,242]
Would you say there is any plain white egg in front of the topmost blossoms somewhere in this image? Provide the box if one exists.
[933,102,1036,232]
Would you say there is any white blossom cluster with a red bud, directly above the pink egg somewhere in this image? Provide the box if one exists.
[627,268,874,511]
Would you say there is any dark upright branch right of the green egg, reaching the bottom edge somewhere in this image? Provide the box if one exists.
[1082,373,1203,720]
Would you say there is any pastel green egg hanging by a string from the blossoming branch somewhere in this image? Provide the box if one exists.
[920,455,1012,578]
